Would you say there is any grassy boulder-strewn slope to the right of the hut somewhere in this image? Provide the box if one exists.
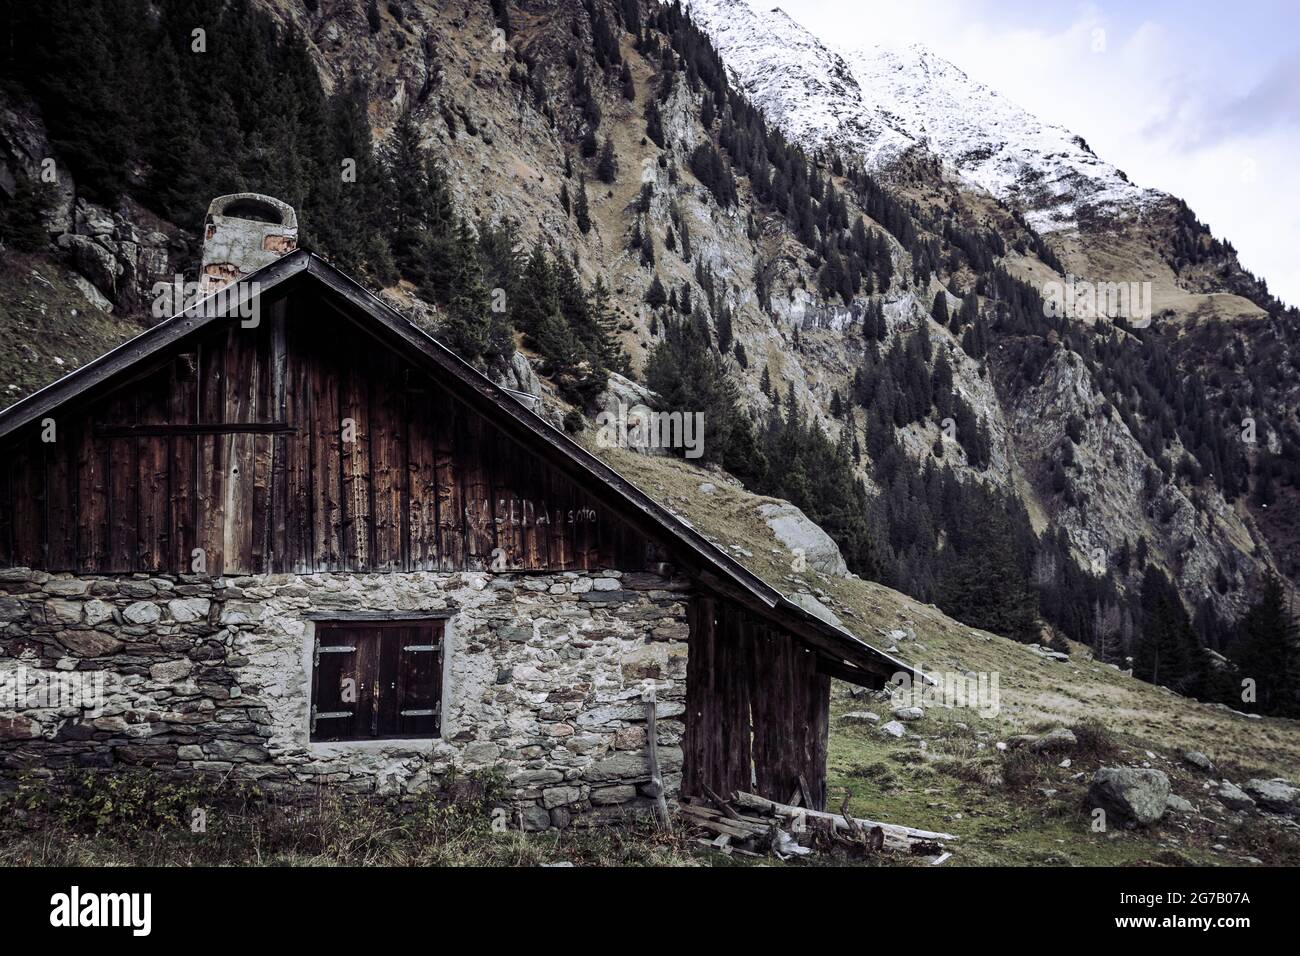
[595,449,1300,865]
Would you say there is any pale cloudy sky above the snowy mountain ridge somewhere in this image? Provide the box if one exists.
[748,0,1300,304]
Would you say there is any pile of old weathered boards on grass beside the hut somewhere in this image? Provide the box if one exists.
[679,788,957,865]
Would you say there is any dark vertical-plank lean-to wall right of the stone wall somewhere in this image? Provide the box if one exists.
[683,594,831,809]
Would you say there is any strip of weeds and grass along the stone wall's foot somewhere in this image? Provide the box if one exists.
[0,770,724,866]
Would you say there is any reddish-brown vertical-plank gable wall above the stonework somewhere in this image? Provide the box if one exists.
[0,290,649,575]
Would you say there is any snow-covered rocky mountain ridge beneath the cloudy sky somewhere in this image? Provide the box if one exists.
[688,0,1165,232]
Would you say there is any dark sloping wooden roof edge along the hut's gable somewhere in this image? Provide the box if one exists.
[0,250,927,684]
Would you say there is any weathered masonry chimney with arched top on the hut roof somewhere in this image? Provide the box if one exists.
[200,193,298,295]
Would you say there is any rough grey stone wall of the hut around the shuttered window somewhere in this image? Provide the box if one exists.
[0,568,689,830]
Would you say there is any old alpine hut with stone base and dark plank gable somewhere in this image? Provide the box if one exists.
[0,196,911,829]
